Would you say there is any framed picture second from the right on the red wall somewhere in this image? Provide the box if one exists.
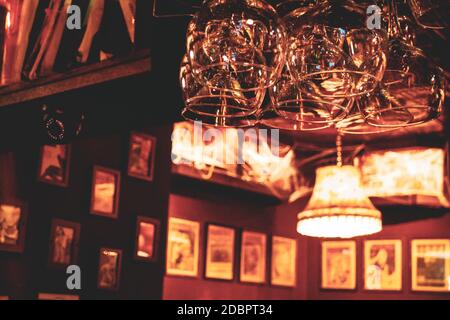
[364,240,402,291]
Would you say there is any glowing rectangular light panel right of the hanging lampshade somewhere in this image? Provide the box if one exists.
[360,148,449,206]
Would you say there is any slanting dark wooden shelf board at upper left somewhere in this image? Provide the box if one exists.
[0,50,151,107]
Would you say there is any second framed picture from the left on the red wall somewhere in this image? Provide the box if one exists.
[205,224,236,280]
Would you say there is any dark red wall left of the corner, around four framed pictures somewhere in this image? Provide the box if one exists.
[163,190,306,300]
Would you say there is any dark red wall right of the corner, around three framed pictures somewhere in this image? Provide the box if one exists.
[277,199,450,300]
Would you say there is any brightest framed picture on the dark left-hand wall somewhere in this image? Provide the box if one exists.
[91,166,120,218]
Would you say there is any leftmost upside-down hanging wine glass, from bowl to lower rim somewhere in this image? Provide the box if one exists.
[184,0,286,126]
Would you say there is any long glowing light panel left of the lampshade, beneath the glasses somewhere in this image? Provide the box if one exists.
[172,122,300,194]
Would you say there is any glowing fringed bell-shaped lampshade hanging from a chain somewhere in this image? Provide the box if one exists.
[297,166,382,238]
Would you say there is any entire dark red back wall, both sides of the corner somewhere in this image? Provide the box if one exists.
[164,188,450,300]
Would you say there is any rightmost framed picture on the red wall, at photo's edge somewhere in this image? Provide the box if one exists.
[411,239,450,291]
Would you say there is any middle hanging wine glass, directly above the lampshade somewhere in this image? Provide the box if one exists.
[270,0,387,129]
